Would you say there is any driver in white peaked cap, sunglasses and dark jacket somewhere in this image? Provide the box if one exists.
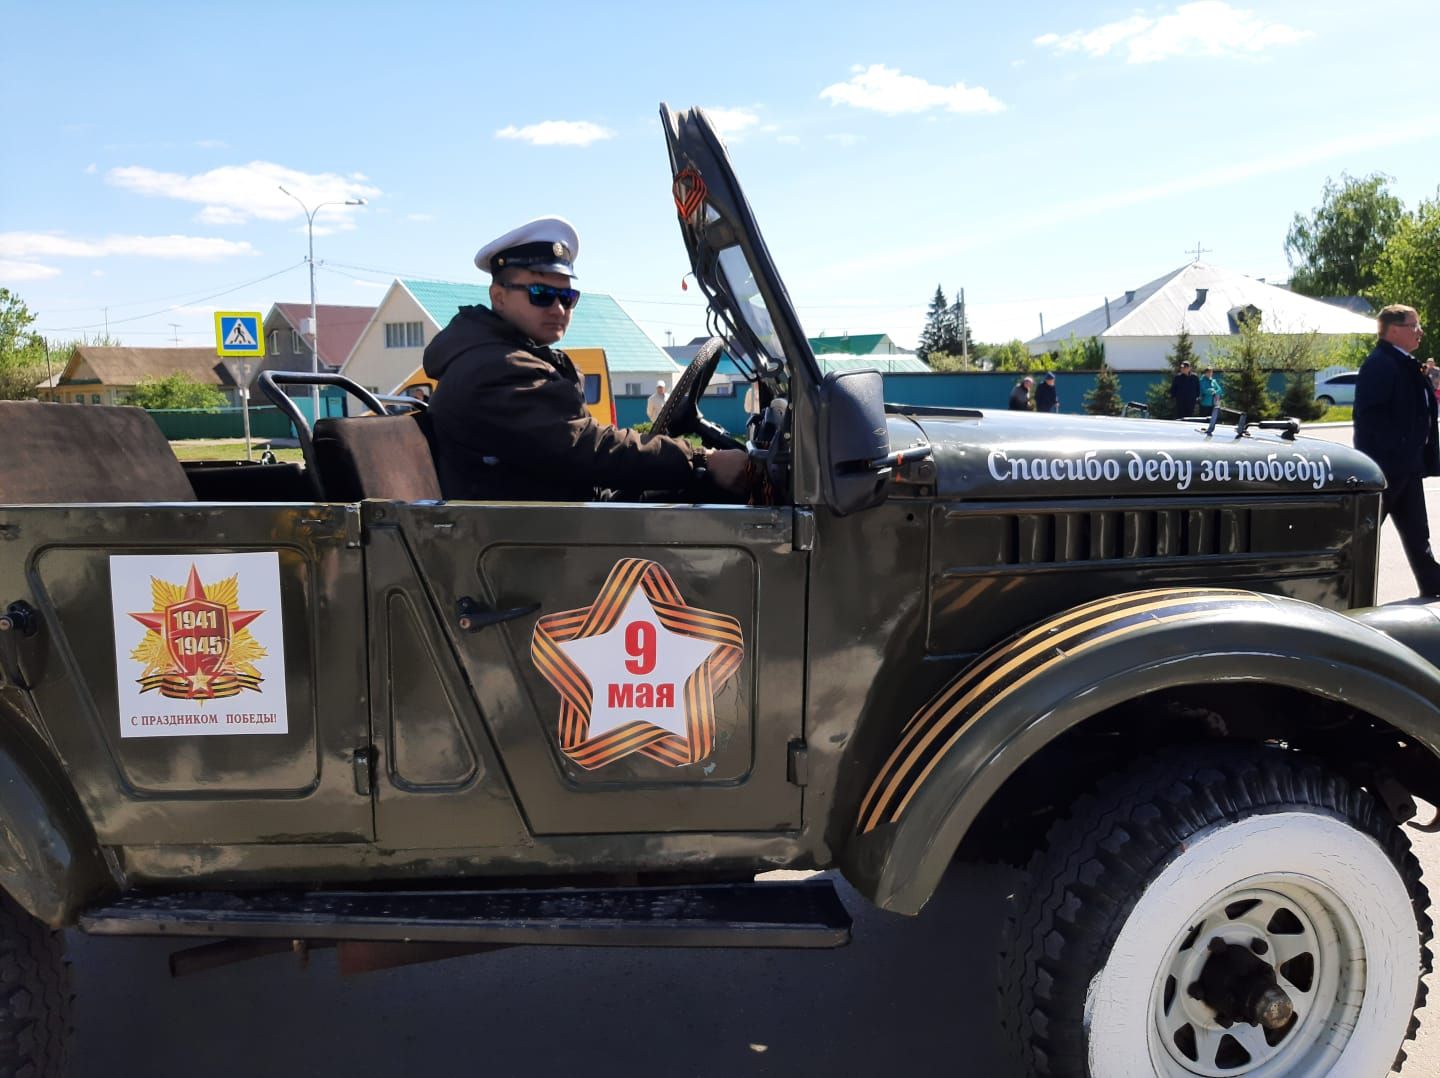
[425,217,746,501]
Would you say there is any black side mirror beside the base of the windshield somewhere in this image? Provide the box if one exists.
[819,370,891,517]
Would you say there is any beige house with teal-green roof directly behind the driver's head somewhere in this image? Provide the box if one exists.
[340,278,680,408]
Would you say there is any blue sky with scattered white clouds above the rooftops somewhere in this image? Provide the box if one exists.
[0,0,1440,347]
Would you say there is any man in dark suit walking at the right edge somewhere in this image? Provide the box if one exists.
[1355,304,1440,596]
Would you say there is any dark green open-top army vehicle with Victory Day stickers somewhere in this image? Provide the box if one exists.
[0,109,1440,1075]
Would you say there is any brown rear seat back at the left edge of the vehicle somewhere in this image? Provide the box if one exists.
[0,400,196,505]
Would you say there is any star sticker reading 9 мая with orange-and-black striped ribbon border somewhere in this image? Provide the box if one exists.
[530,558,744,770]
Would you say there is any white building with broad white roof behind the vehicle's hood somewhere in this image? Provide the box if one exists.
[1025,262,1375,370]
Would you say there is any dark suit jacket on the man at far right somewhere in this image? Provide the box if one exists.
[1354,341,1440,488]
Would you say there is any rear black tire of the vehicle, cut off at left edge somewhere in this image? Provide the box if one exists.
[0,894,71,1078]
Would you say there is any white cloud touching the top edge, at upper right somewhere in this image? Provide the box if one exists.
[1035,0,1312,63]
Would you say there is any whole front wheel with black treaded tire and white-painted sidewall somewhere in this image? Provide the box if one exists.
[1001,746,1431,1078]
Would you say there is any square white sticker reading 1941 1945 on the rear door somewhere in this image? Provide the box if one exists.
[109,551,289,737]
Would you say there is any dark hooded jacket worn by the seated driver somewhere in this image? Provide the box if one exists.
[425,307,700,501]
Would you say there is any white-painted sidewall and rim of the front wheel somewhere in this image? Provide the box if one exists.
[1084,812,1420,1078]
